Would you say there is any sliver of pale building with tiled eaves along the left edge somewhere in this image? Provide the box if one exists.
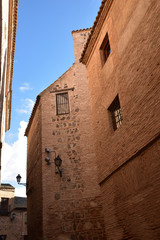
[0,0,18,184]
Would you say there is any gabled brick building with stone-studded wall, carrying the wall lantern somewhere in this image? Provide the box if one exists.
[25,29,105,240]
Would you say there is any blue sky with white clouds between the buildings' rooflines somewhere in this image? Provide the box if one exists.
[2,0,101,196]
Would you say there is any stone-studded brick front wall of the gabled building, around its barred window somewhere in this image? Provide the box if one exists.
[41,31,105,240]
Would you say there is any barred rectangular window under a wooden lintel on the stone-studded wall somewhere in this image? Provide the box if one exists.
[56,93,69,115]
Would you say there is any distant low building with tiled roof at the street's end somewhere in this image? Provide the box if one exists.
[0,184,27,240]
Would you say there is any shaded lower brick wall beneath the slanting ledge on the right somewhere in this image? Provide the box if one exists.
[101,139,160,240]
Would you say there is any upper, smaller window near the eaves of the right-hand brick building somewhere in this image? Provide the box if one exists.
[100,33,111,65]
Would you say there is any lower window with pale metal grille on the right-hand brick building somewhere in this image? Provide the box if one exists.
[108,95,123,130]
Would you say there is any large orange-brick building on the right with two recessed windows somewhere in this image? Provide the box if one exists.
[81,0,160,240]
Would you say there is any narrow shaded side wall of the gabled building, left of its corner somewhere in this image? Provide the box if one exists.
[27,103,43,240]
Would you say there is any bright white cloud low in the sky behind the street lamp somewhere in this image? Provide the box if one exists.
[2,121,27,196]
